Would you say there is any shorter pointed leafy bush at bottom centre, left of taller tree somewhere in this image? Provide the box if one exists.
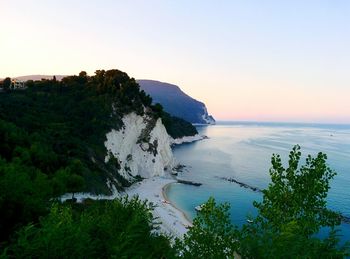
[175,198,237,259]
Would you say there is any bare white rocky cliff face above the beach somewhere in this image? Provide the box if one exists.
[105,113,174,180]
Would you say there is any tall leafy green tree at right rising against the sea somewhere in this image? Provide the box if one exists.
[239,146,347,258]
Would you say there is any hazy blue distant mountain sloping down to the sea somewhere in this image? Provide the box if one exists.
[137,80,215,124]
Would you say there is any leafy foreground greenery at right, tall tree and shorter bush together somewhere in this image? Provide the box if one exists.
[175,146,350,258]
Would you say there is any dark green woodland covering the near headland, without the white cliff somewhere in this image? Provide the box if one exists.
[0,70,197,248]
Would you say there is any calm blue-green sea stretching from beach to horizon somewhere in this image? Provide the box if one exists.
[167,122,350,244]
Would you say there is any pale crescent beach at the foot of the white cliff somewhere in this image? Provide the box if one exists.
[125,177,192,238]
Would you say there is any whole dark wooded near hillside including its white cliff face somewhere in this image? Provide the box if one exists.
[0,70,197,245]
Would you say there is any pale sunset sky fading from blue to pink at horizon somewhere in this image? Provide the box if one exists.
[0,0,350,123]
